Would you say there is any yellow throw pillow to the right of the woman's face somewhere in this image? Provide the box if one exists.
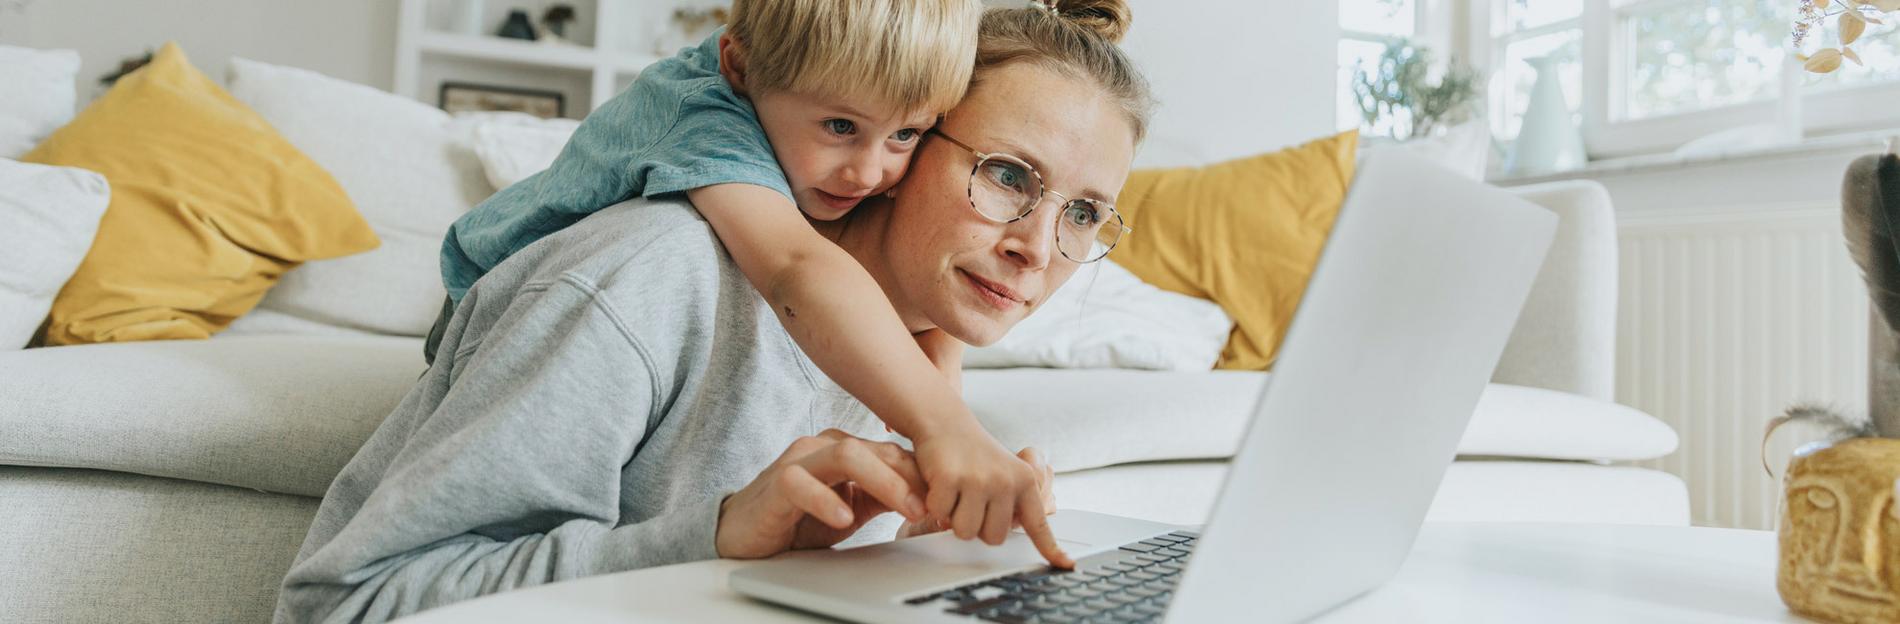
[1113,131,1359,371]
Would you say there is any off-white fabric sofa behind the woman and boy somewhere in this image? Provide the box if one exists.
[0,54,1689,622]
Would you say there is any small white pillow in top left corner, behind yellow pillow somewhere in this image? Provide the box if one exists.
[0,46,80,158]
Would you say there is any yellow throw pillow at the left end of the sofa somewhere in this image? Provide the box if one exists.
[21,44,380,344]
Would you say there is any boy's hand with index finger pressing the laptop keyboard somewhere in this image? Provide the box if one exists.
[916,422,1075,569]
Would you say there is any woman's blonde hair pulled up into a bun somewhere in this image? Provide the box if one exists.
[971,0,1155,143]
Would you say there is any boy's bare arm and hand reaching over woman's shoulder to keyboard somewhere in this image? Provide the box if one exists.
[686,185,1074,567]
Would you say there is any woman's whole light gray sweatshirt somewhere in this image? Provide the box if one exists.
[276,200,884,622]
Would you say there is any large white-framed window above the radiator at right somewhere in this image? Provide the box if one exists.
[1467,0,1900,158]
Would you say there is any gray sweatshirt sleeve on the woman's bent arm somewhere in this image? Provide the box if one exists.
[267,282,722,622]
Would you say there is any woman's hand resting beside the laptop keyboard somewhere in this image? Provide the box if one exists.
[713,430,923,559]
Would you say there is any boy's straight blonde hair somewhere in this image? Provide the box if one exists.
[728,0,982,112]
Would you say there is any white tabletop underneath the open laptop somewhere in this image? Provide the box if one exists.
[405,523,1807,624]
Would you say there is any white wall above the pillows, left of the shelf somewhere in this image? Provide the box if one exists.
[0,0,397,103]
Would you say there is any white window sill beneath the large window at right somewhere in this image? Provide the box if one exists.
[1484,127,1900,186]
